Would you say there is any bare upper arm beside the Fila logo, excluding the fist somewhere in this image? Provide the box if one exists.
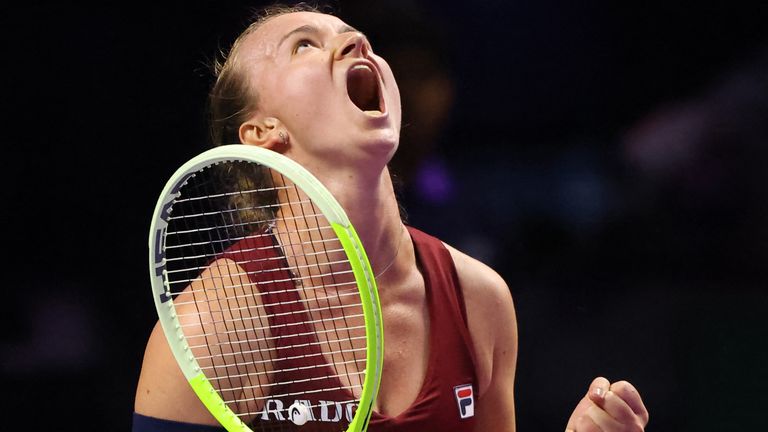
[448,246,517,432]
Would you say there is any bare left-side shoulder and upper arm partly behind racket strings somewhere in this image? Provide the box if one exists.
[134,259,269,425]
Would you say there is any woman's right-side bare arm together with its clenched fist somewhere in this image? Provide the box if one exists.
[448,246,648,432]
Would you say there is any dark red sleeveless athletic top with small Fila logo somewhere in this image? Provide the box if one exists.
[134,227,477,432]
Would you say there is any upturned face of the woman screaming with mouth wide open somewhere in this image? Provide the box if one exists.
[238,12,401,170]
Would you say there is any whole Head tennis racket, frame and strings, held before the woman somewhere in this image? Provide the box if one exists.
[149,145,383,432]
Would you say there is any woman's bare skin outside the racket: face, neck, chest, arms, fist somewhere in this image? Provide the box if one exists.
[135,12,648,432]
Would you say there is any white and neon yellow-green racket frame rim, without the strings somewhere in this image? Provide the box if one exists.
[149,144,384,432]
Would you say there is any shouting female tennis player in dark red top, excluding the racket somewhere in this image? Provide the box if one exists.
[133,6,648,432]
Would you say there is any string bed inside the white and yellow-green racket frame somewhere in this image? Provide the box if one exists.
[166,161,366,430]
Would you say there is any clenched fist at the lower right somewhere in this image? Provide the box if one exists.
[565,377,648,432]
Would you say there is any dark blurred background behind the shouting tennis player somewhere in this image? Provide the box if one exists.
[0,0,768,432]
